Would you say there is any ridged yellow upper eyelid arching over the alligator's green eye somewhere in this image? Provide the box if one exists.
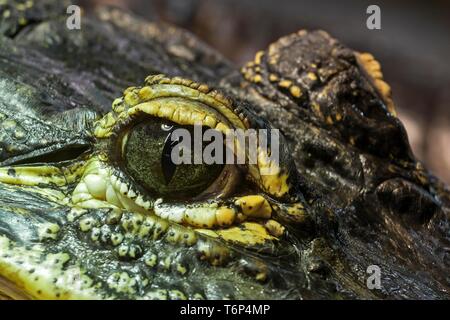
[94,75,247,138]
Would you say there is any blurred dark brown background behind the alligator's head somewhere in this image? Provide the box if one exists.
[78,0,450,183]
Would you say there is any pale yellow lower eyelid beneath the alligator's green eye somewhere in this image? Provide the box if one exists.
[73,160,284,243]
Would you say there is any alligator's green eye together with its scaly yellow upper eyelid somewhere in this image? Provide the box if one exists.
[93,75,290,204]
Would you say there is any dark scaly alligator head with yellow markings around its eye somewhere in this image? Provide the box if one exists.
[0,0,450,299]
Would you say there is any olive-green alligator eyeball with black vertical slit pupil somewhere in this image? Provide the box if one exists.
[121,118,229,199]
